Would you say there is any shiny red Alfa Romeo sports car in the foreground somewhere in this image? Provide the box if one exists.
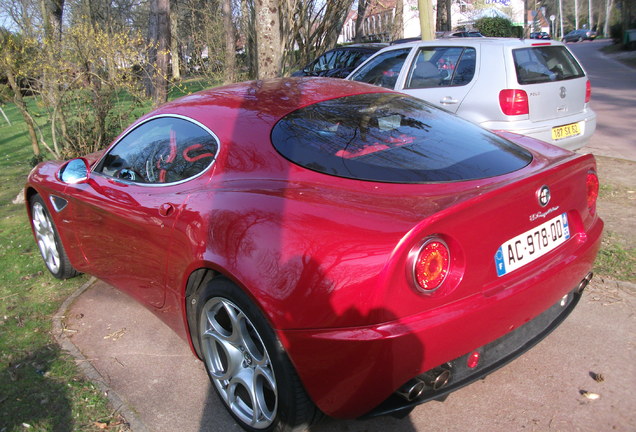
[26,78,603,430]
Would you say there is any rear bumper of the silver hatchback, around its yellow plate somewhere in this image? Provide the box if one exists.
[480,109,596,151]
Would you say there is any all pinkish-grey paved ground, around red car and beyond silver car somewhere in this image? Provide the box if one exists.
[55,38,636,432]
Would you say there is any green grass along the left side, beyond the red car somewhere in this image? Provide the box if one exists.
[0,79,216,432]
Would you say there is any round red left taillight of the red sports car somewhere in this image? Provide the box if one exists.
[413,239,450,292]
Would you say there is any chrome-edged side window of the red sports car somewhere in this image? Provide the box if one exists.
[95,117,218,184]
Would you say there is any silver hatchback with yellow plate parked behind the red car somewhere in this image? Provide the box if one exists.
[347,38,596,150]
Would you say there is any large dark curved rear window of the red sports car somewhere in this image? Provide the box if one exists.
[272,93,532,183]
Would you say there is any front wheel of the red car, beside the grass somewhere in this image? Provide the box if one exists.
[29,195,79,279]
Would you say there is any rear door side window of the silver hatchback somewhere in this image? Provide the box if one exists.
[405,47,476,89]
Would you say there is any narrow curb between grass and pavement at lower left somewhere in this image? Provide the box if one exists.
[53,277,150,432]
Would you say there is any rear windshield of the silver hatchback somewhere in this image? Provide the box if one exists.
[512,45,585,84]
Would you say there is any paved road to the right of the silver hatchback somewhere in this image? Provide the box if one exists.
[568,41,636,161]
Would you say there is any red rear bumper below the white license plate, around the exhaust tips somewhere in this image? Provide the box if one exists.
[278,219,603,418]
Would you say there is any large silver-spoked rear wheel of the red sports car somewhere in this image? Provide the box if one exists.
[197,279,319,431]
